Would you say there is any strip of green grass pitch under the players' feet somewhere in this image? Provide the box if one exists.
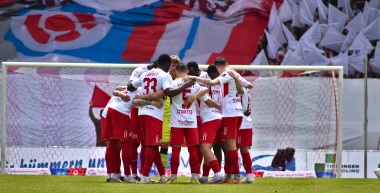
[0,175,380,193]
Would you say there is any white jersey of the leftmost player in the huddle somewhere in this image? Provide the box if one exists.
[102,88,141,118]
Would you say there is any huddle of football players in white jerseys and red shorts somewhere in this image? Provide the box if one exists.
[102,54,254,184]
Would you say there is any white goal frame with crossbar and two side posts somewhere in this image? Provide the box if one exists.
[1,62,343,178]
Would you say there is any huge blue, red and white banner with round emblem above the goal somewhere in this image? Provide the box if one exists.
[5,0,281,65]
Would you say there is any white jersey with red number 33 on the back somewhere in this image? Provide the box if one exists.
[132,68,172,121]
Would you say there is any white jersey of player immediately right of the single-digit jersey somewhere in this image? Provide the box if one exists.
[200,85,222,123]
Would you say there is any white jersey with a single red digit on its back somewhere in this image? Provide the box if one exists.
[170,78,207,128]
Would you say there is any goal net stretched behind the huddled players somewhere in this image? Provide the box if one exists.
[1,62,342,176]
